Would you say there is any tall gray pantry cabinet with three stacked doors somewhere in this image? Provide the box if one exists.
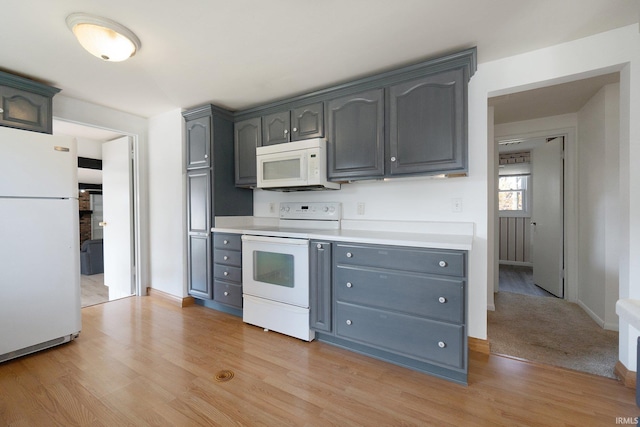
[182,104,253,299]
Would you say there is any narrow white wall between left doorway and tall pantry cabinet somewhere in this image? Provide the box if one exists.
[149,110,187,297]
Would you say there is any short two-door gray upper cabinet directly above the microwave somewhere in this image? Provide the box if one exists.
[262,102,324,145]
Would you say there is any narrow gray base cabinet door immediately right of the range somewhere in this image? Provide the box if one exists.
[309,241,331,332]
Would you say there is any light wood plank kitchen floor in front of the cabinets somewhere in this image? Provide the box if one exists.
[0,297,640,426]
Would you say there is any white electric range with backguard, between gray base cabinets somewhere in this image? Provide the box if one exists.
[242,202,342,341]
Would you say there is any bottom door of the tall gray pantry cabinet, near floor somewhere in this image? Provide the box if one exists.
[187,235,213,299]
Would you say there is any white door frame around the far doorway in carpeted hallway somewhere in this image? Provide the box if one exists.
[490,125,578,302]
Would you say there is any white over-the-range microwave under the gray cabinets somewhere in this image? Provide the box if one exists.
[256,138,340,191]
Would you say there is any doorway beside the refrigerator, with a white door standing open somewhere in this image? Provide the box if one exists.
[54,120,139,307]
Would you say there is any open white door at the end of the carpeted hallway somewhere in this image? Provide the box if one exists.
[531,137,564,298]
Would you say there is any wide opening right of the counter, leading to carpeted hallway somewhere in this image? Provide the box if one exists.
[488,73,619,377]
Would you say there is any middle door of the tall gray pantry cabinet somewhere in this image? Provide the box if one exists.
[187,169,211,234]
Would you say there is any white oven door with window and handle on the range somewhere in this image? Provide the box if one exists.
[242,235,309,308]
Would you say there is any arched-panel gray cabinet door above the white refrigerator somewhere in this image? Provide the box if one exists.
[0,86,52,133]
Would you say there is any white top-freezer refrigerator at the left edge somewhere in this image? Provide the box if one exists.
[0,127,81,362]
